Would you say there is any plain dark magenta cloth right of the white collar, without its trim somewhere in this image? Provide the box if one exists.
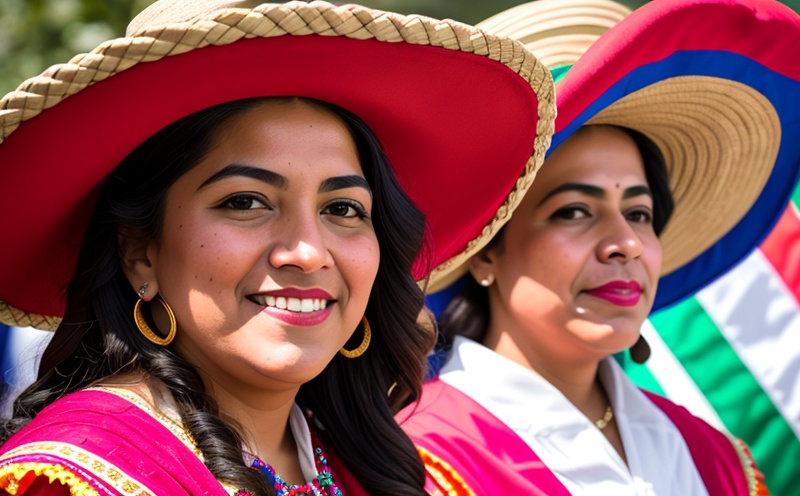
[643,391,750,496]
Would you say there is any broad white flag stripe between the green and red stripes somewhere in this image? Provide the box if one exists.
[696,251,800,438]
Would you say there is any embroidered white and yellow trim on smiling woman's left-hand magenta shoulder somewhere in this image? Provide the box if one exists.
[0,442,155,496]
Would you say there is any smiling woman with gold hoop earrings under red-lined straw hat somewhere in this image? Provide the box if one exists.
[0,0,554,495]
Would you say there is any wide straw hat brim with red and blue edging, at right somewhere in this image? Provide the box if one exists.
[432,0,800,310]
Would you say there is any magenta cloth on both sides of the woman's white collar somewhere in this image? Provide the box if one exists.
[404,378,750,496]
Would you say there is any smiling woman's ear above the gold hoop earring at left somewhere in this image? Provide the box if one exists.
[117,229,158,301]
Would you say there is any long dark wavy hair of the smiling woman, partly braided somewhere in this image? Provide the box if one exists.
[2,98,433,495]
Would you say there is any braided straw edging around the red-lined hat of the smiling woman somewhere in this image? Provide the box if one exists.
[0,1,555,329]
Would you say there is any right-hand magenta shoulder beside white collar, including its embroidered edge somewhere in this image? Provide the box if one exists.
[643,390,769,496]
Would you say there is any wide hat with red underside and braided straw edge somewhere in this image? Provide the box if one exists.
[0,0,555,329]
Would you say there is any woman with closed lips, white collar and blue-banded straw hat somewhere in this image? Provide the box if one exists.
[398,0,800,496]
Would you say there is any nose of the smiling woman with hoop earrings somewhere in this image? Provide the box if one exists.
[269,213,333,273]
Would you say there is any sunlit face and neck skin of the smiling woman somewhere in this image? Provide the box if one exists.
[123,101,380,483]
